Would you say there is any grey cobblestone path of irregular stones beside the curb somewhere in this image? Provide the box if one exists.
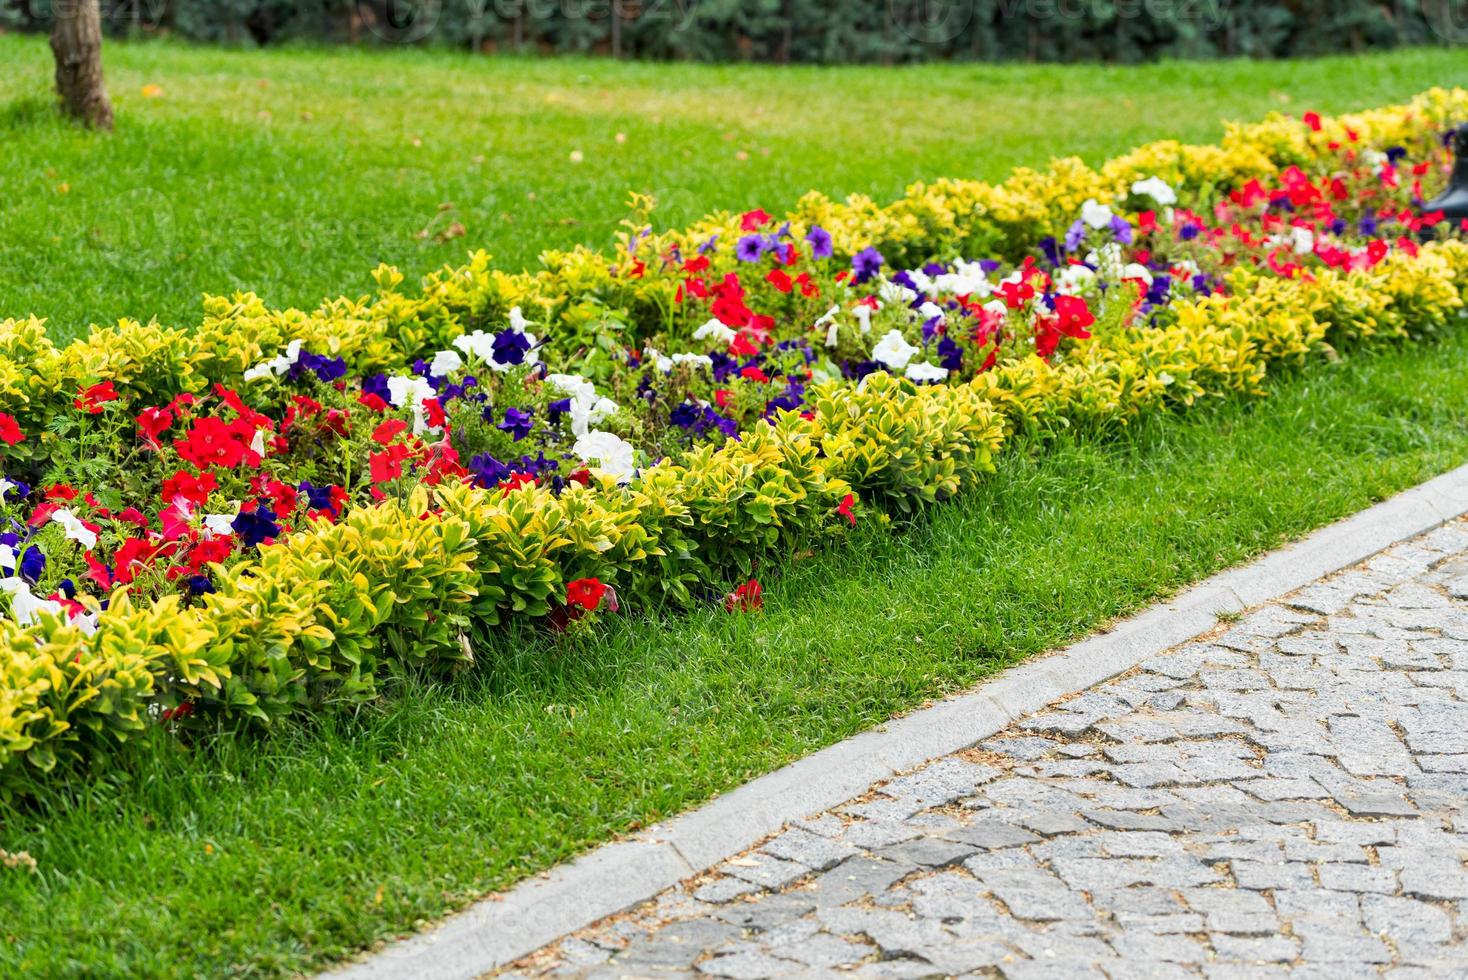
[505,522,1468,980]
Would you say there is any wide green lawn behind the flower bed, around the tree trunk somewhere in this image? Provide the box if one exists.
[0,35,1464,337]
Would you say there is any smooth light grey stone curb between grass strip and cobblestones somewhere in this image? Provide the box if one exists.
[323,465,1468,980]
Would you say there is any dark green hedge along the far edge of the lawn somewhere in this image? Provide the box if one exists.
[0,0,1468,63]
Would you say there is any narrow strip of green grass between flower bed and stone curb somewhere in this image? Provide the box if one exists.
[0,332,1468,977]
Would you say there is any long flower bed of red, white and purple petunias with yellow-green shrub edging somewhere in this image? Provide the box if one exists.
[0,91,1468,792]
